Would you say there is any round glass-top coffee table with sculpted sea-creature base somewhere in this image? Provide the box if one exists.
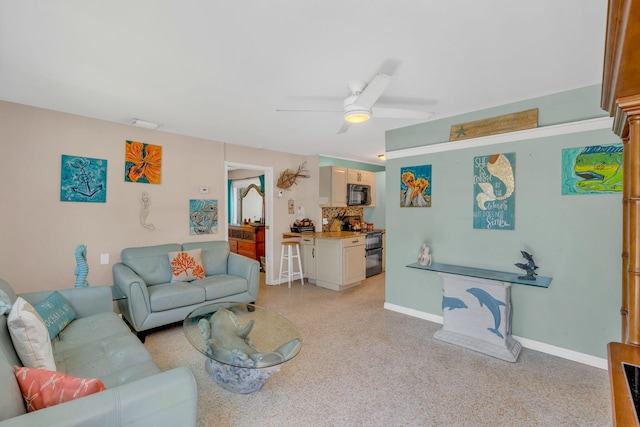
[183,302,302,393]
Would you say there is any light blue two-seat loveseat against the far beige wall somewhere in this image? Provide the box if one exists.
[113,240,260,342]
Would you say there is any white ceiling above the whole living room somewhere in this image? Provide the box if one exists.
[0,0,607,163]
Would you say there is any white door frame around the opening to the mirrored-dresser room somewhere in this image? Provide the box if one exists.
[223,161,275,284]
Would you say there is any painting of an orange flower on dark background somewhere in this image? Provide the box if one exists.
[124,141,162,184]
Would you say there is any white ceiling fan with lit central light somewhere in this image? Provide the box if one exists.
[276,73,434,134]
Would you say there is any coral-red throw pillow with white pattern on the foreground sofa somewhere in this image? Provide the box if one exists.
[15,366,106,412]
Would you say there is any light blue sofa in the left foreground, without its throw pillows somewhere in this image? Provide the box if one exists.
[0,279,198,427]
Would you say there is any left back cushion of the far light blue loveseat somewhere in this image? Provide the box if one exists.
[120,243,182,286]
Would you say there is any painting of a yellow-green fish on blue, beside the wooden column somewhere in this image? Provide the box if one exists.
[562,144,624,195]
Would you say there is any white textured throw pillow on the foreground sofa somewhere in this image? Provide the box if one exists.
[7,297,56,371]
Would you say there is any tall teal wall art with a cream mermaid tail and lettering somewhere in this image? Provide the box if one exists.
[473,153,516,230]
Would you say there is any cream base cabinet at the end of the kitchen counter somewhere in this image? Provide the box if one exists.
[316,236,367,291]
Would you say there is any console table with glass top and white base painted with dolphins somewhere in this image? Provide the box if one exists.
[407,262,551,362]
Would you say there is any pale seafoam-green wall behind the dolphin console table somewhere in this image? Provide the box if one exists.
[385,86,622,358]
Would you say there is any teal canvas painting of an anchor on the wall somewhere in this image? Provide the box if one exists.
[60,154,107,203]
